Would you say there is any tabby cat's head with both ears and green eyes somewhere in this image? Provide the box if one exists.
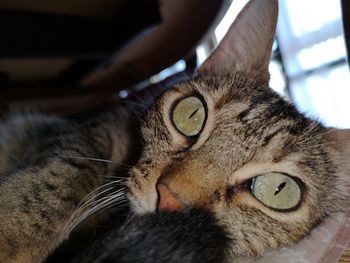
[128,0,350,254]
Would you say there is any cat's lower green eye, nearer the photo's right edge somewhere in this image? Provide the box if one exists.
[251,173,301,210]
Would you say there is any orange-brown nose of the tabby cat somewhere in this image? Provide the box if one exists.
[156,183,185,212]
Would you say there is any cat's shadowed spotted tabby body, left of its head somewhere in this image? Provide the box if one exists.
[0,112,130,262]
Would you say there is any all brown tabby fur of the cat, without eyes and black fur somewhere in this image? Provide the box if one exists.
[0,0,350,262]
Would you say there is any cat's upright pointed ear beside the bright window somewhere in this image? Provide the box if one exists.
[198,0,278,81]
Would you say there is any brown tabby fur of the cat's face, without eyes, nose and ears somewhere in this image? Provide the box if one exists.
[129,73,345,255]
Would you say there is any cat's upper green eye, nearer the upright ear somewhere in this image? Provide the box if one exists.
[172,96,205,136]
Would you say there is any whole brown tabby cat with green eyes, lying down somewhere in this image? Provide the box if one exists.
[0,0,350,262]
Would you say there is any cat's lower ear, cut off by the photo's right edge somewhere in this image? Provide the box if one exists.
[323,129,350,215]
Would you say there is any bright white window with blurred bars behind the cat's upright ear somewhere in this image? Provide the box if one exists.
[277,0,350,128]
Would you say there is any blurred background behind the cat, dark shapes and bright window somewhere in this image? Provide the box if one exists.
[0,0,350,128]
